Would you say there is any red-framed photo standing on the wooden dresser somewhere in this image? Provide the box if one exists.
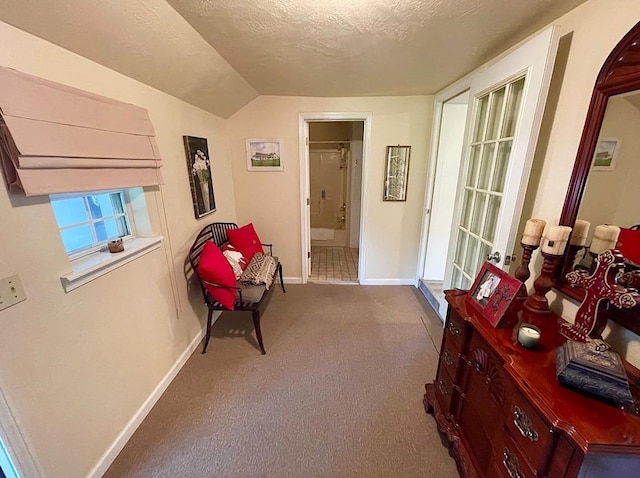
[466,262,524,328]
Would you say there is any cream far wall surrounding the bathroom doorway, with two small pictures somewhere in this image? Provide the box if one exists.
[229,96,433,283]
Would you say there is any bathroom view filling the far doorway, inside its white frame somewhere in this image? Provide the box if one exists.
[307,121,364,283]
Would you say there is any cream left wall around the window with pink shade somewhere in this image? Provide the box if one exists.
[0,23,235,478]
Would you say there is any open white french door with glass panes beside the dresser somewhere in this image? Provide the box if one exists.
[444,27,559,289]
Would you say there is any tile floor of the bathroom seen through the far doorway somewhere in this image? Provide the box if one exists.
[309,246,358,283]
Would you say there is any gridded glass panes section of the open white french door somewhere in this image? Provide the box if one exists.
[451,76,525,289]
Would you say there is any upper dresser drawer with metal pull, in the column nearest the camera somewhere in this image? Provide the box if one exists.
[505,390,555,470]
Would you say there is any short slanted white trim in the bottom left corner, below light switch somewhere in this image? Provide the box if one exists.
[0,387,43,478]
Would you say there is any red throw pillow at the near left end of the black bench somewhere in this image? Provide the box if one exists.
[198,241,237,310]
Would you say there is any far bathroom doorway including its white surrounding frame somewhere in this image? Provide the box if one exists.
[299,113,371,284]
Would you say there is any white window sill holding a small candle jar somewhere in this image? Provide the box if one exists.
[60,236,162,292]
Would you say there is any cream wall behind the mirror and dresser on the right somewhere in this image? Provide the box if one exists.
[520,0,640,366]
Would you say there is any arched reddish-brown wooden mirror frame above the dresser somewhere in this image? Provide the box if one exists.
[556,22,640,334]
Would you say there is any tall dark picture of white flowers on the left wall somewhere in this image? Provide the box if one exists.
[182,136,216,219]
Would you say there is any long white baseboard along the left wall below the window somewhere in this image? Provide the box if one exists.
[87,330,205,478]
